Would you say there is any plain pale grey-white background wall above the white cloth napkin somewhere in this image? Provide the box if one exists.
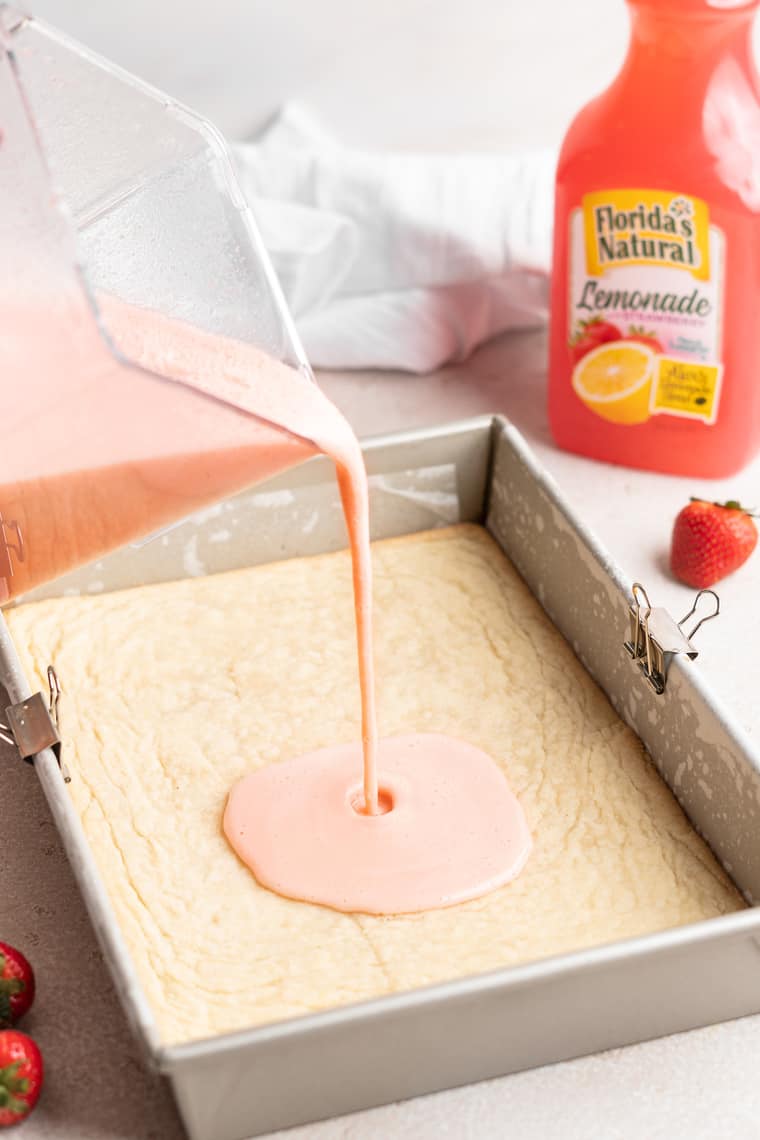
[25,0,627,150]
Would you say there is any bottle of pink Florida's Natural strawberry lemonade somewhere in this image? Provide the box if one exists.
[549,0,760,477]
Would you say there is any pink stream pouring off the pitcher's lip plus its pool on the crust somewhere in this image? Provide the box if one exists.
[105,306,531,914]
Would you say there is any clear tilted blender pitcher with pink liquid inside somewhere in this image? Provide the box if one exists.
[0,3,314,603]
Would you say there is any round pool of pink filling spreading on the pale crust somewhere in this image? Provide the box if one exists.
[223,733,531,914]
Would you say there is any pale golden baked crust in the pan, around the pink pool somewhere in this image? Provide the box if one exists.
[7,526,744,1043]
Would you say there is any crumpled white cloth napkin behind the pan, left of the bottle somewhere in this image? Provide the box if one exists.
[235,105,556,372]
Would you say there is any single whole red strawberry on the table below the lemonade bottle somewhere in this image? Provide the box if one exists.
[670,498,758,589]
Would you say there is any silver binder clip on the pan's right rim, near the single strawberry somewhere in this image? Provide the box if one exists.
[623,581,720,694]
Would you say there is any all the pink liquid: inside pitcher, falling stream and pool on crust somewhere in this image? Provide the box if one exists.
[5,296,531,913]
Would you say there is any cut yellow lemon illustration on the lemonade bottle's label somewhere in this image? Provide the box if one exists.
[572,341,656,424]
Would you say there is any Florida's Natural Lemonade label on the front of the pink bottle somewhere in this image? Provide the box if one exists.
[569,189,726,424]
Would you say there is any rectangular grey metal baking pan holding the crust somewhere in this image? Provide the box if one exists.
[0,418,760,1140]
